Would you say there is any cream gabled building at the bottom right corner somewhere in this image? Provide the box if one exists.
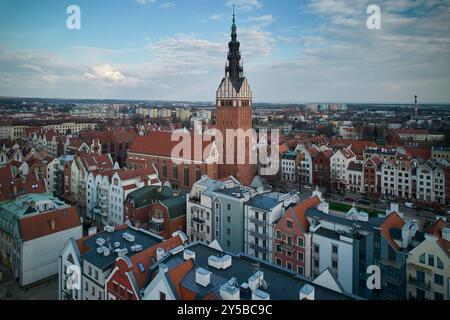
[406,219,450,300]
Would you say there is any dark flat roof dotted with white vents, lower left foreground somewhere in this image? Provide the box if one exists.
[81,228,162,270]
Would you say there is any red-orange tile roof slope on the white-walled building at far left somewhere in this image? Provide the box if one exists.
[19,207,81,241]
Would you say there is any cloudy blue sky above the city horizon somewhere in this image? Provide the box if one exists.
[0,0,450,103]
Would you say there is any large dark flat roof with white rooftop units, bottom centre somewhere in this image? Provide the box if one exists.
[158,243,360,300]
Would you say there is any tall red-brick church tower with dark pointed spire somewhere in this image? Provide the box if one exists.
[216,9,254,185]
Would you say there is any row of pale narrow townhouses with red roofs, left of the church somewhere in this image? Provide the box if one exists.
[60,153,170,226]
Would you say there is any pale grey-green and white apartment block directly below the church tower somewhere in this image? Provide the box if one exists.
[186,176,299,261]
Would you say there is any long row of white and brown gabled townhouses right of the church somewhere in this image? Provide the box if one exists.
[280,144,450,204]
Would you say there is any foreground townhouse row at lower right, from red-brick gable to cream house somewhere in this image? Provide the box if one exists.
[274,193,450,300]
